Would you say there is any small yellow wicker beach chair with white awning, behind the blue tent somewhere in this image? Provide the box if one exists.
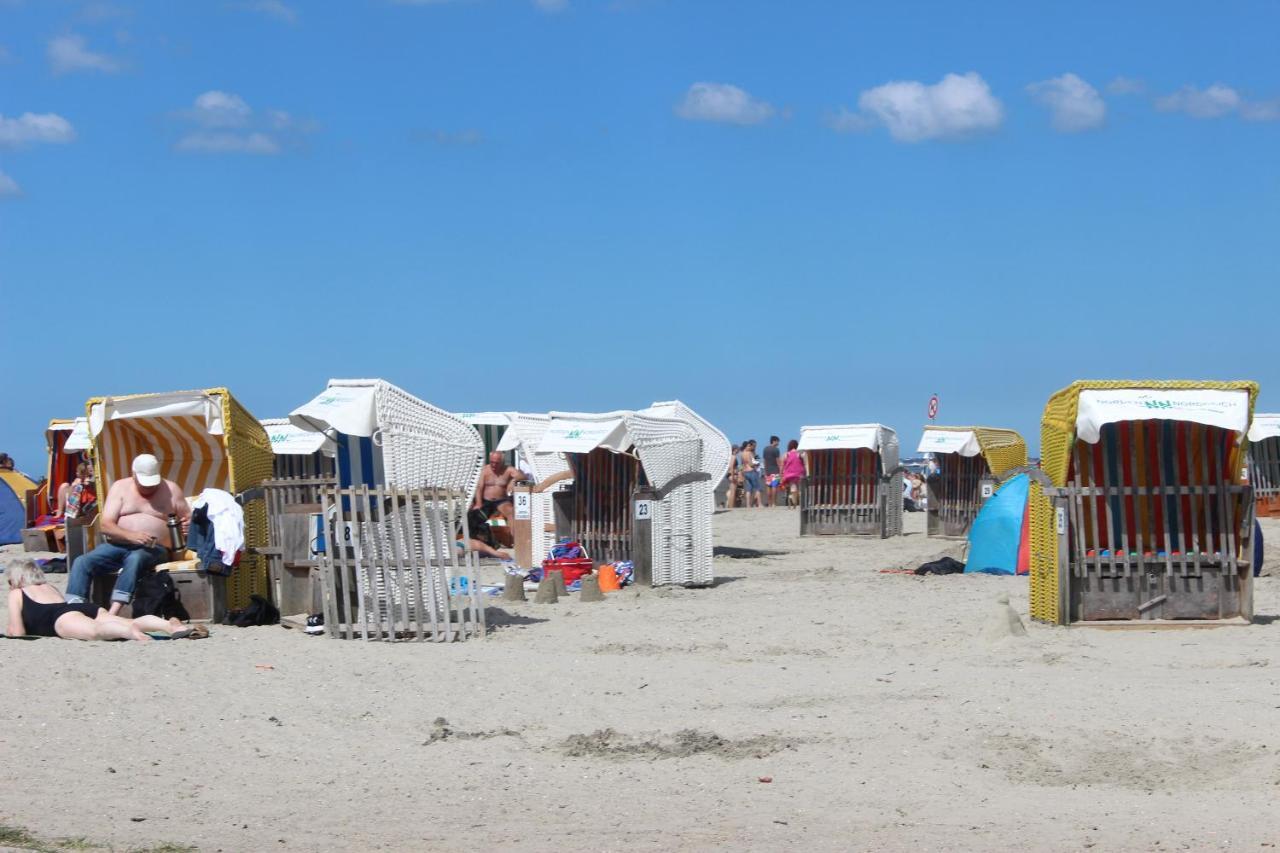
[916,424,1027,539]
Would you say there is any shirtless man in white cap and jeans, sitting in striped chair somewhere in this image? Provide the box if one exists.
[67,453,191,616]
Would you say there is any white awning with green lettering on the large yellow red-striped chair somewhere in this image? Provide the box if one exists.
[1075,388,1249,444]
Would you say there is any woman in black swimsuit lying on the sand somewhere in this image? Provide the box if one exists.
[5,557,209,642]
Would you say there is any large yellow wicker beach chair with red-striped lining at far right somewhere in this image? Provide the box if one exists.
[1028,380,1257,625]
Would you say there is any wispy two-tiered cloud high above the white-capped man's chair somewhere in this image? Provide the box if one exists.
[174,90,319,154]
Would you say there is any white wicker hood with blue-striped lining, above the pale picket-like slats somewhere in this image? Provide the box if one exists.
[289,379,484,494]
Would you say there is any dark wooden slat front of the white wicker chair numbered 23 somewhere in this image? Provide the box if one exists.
[568,447,645,564]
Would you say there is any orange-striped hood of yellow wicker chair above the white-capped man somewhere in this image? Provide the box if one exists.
[87,388,273,496]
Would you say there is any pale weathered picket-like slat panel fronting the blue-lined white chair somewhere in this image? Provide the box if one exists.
[320,487,485,642]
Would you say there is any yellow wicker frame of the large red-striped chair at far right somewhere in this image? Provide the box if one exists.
[1028,379,1258,625]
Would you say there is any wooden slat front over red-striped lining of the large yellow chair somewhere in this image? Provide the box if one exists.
[1047,420,1253,621]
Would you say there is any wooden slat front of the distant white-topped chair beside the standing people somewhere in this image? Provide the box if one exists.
[800,448,902,537]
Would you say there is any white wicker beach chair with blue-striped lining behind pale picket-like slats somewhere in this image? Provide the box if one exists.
[289,379,484,639]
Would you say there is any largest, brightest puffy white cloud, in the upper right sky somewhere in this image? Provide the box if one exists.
[833,72,1005,142]
